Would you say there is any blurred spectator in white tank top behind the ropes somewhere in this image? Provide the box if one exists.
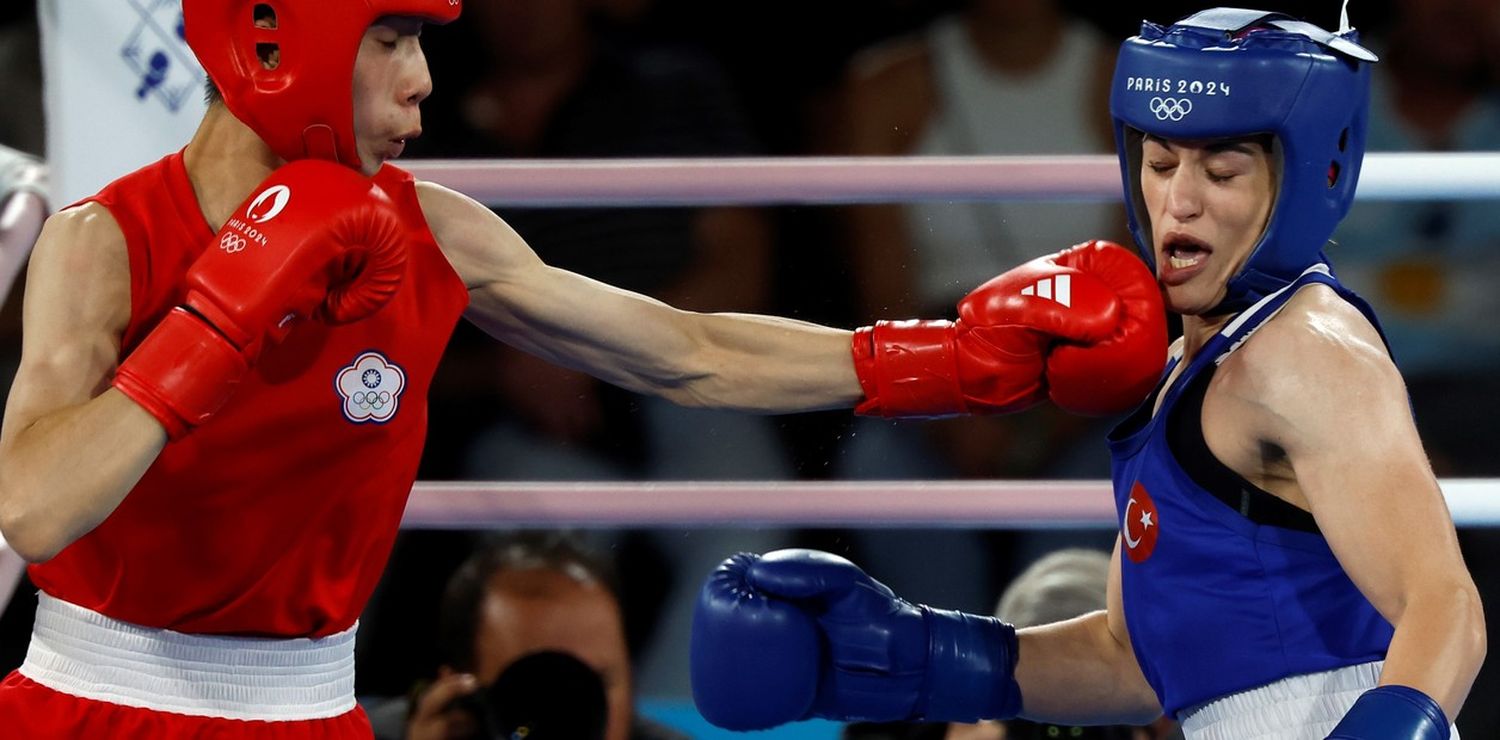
[831,0,1130,611]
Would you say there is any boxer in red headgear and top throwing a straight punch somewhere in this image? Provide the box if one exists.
[0,0,1166,738]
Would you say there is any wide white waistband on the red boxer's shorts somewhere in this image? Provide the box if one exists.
[21,593,357,722]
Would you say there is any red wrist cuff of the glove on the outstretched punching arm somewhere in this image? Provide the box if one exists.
[852,321,969,419]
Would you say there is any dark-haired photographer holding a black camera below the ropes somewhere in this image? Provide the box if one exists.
[371,534,681,740]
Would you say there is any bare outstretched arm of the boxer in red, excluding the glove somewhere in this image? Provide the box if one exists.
[419,177,864,411]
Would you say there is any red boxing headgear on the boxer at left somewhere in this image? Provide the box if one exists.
[183,0,464,168]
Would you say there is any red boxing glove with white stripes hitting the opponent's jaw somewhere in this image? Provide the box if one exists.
[854,242,1167,417]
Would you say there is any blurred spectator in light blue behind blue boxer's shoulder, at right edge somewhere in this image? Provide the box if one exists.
[1332,0,1500,476]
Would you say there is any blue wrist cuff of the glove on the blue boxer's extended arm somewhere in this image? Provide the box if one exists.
[920,606,1022,722]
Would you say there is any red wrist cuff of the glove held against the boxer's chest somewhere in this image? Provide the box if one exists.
[113,308,249,440]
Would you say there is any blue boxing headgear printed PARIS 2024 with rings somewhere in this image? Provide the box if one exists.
[1110,8,1377,314]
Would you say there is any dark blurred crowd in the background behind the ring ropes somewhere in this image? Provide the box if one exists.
[0,0,1500,737]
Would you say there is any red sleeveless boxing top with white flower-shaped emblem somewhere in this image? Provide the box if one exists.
[30,153,468,636]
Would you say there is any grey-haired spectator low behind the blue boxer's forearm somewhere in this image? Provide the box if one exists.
[843,548,1182,740]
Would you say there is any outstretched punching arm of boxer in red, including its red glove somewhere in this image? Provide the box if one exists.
[419,185,1167,417]
